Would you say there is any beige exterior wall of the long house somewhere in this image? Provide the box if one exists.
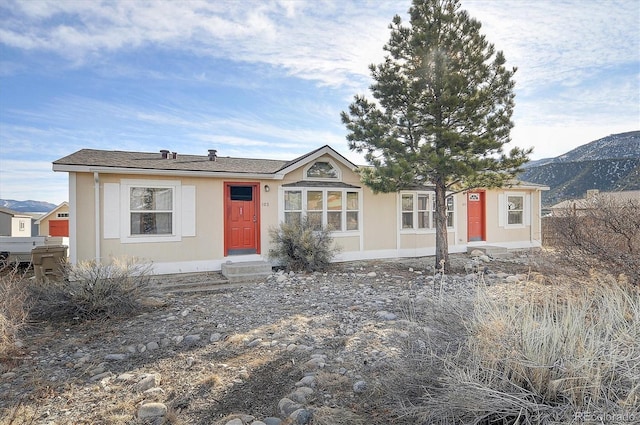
[71,157,540,272]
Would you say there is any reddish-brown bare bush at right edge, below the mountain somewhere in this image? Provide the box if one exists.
[549,196,640,285]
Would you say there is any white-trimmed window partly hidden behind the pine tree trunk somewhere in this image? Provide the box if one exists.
[400,192,454,230]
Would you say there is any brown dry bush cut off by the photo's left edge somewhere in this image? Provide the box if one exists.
[0,264,29,359]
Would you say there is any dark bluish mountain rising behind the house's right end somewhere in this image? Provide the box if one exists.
[519,131,640,207]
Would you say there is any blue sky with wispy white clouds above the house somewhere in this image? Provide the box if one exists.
[0,0,640,204]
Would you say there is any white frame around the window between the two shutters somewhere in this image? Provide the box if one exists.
[120,179,182,243]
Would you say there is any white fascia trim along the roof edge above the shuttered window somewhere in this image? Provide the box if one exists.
[53,164,281,180]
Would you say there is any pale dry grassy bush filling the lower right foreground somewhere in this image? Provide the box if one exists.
[411,275,640,424]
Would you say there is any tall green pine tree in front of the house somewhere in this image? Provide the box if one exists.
[341,0,532,269]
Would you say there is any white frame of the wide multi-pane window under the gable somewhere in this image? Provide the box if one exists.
[279,187,363,236]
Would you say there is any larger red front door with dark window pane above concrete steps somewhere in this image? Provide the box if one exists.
[224,183,260,256]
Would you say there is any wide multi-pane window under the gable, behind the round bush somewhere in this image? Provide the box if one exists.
[284,188,360,232]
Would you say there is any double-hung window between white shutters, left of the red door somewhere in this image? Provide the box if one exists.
[129,186,175,236]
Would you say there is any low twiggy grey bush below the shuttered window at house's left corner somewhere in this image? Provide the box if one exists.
[30,259,151,319]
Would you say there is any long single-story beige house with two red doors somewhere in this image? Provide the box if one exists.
[53,146,548,273]
